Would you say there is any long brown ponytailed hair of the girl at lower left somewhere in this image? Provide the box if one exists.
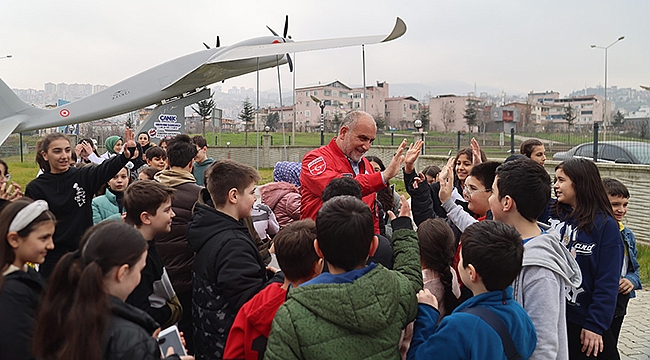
[34,221,147,360]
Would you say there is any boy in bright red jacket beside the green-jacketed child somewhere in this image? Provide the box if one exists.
[223,219,323,360]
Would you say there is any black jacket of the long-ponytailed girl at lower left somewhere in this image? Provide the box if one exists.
[102,296,179,360]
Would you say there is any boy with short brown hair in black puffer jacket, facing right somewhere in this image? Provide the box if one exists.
[187,160,283,359]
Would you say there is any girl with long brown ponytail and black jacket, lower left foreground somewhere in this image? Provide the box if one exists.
[34,221,193,360]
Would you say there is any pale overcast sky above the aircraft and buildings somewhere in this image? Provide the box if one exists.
[0,0,650,96]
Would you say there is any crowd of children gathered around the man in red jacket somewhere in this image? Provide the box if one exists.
[0,129,641,359]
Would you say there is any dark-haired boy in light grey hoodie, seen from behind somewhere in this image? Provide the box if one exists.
[488,159,582,359]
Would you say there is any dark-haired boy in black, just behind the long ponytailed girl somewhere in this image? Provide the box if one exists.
[124,180,182,329]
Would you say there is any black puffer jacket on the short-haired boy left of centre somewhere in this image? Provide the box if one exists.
[187,189,283,359]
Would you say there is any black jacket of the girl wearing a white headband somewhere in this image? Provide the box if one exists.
[0,268,45,360]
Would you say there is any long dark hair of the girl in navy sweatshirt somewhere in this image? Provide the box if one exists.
[552,158,614,234]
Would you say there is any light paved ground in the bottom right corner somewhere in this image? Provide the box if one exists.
[618,290,650,360]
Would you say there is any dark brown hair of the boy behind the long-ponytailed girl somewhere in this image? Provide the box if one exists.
[124,180,174,226]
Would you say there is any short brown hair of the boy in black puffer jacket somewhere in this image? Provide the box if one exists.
[206,160,260,206]
